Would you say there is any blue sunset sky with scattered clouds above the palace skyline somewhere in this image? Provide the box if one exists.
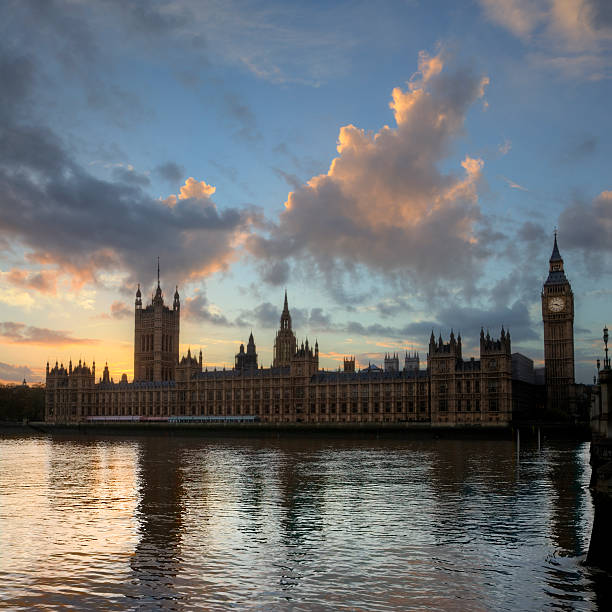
[0,0,612,382]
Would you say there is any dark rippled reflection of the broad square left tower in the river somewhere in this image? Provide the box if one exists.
[126,437,184,610]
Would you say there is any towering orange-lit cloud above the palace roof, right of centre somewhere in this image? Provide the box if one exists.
[247,52,488,298]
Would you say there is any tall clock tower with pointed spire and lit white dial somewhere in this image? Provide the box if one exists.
[542,231,574,412]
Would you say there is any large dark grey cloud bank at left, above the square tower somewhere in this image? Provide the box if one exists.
[0,73,259,286]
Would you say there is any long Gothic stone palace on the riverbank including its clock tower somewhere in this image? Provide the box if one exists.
[45,235,574,427]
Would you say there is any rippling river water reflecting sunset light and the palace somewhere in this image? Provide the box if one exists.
[0,437,610,610]
